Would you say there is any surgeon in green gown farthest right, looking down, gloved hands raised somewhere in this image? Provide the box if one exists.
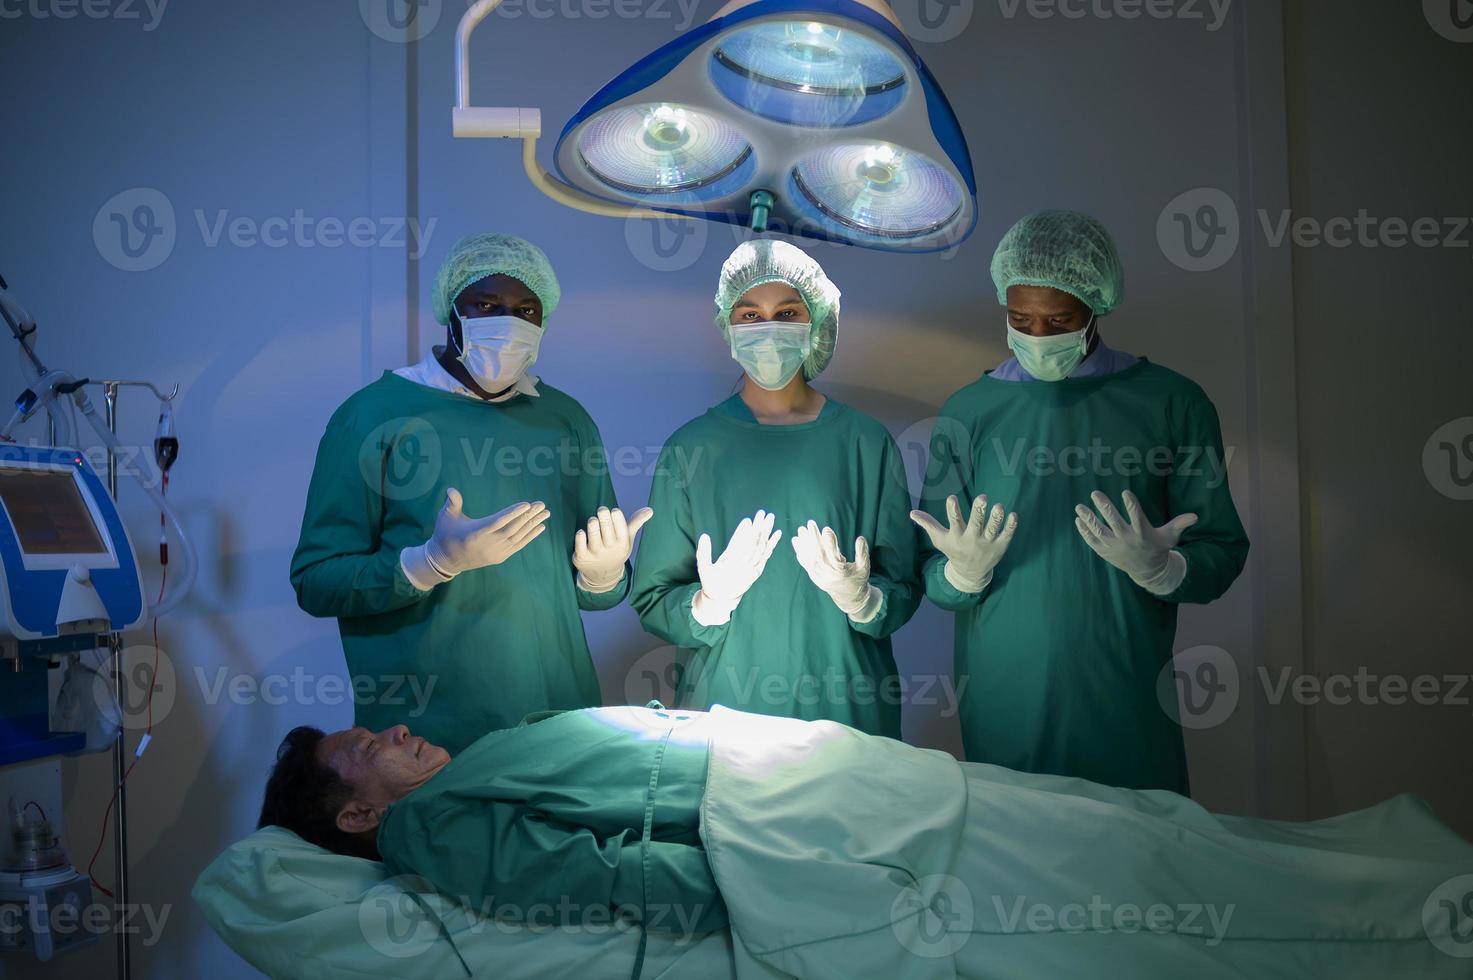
[915,211,1248,794]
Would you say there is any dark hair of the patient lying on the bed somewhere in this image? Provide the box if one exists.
[256,725,379,861]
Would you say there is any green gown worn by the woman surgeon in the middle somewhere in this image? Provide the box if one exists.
[629,395,922,738]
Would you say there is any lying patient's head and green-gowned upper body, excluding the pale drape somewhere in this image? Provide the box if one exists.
[258,712,726,936]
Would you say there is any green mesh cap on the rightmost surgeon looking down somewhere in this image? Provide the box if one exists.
[993,211,1125,317]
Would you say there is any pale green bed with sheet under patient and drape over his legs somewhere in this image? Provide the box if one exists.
[193,707,1473,980]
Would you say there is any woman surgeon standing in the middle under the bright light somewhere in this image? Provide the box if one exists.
[630,240,922,738]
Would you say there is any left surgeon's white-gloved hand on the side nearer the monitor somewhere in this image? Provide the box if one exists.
[399,486,549,589]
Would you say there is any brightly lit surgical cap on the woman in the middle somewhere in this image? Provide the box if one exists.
[716,239,838,380]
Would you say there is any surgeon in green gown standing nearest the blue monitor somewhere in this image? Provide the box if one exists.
[292,234,650,752]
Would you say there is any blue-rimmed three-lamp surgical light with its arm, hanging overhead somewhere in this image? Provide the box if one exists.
[454,0,977,252]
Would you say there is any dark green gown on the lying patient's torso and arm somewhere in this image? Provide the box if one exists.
[379,707,726,936]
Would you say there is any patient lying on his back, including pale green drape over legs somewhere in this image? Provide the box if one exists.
[261,706,1473,980]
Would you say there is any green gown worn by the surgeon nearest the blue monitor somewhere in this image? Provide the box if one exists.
[292,371,629,752]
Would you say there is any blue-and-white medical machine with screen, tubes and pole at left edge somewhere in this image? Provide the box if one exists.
[0,269,197,980]
